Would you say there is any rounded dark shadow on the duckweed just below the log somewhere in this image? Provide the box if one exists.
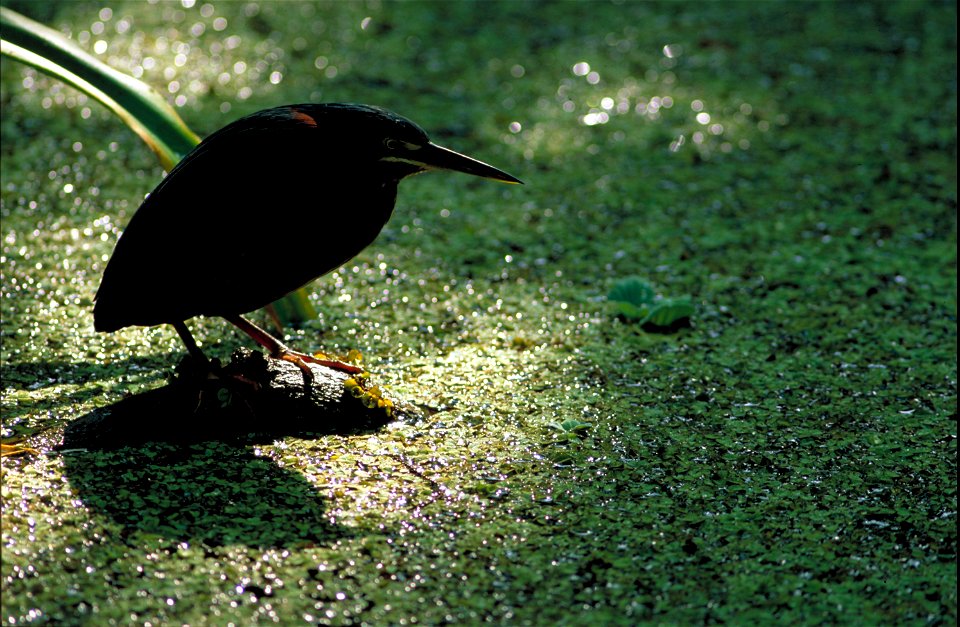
[64,442,350,548]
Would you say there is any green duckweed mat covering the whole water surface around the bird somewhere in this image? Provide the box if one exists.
[0,0,957,625]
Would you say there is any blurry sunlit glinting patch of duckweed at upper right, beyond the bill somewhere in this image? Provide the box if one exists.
[501,37,786,161]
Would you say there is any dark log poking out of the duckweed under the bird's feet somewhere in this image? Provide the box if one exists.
[60,349,402,449]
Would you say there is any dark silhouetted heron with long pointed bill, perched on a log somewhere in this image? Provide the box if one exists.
[93,104,520,378]
